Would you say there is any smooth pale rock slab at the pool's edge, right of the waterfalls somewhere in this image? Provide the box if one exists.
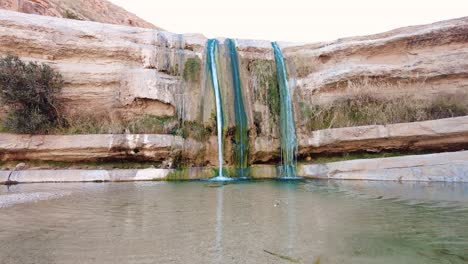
[298,151,468,182]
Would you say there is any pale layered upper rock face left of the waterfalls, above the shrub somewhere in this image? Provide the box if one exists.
[0,10,205,119]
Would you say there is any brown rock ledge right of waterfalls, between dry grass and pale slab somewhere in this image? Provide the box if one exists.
[299,116,468,156]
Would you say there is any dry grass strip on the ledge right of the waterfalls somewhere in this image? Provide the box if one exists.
[300,79,468,131]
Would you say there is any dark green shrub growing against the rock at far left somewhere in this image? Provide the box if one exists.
[0,55,63,133]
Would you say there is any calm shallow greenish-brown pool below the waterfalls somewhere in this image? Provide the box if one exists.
[0,181,468,264]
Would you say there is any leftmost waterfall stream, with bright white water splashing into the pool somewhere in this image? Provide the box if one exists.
[206,39,230,181]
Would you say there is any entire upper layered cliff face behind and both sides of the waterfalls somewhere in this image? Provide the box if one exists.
[0,11,468,167]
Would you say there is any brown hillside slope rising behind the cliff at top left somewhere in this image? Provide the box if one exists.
[0,0,160,29]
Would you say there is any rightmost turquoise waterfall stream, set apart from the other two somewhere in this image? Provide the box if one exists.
[271,42,297,178]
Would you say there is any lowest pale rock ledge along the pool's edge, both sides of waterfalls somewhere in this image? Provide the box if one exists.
[0,151,468,184]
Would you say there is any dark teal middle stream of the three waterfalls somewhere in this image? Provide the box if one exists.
[226,39,249,178]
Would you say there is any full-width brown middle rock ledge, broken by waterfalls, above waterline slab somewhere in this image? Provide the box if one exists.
[0,116,468,164]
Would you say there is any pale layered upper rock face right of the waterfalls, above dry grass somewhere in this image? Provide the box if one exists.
[284,17,468,100]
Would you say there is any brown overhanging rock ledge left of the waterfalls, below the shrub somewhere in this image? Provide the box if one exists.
[0,134,205,166]
